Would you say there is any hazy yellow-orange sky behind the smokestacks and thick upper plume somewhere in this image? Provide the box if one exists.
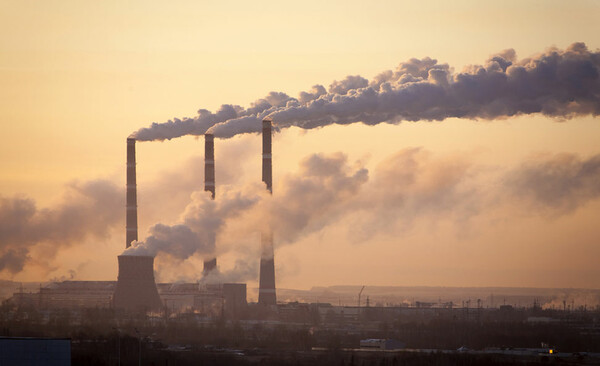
[0,0,600,288]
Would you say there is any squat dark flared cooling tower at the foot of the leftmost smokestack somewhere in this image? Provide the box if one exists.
[113,255,162,311]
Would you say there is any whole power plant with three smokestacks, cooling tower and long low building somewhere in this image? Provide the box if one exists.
[7,119,277,318]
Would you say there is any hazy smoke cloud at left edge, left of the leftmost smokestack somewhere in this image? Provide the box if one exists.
[0,180,124,274]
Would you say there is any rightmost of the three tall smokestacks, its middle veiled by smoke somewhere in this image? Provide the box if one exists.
[258,118,277,305]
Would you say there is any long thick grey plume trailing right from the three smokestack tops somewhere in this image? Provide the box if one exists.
[133,43,600,141]
